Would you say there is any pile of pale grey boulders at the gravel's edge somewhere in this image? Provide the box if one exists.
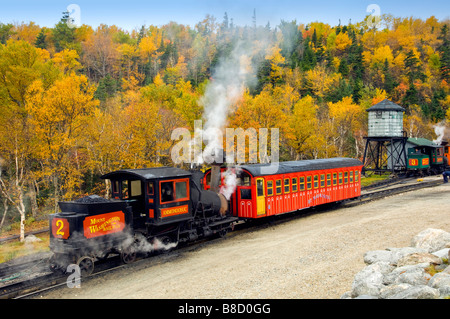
[341,228,450,299]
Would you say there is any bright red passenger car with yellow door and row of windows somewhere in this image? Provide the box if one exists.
[203,158,363,219]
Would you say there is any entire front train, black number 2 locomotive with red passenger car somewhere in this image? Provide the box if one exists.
[49,158,362,275]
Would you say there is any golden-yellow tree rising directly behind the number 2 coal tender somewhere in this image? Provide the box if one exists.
[26,74,99,205]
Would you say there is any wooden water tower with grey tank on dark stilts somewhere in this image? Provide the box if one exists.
[363,100,408,173]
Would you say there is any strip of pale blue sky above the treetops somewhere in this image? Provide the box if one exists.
[0,0,450,30]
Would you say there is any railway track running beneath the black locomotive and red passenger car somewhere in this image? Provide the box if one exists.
[0,177,443,299]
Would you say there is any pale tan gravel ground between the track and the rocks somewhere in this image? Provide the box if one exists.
[37,184,450,299]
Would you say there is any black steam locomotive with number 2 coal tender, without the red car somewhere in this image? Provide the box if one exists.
[50,167,237,274]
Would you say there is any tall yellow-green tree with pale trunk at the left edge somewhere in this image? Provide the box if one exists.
[0,39,49,241]
